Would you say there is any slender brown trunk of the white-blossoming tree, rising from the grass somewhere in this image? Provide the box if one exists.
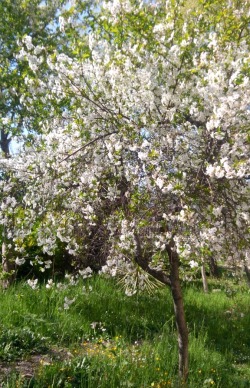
[167,246,188,384]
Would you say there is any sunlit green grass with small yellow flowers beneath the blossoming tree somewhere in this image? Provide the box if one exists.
[0,277,250,388]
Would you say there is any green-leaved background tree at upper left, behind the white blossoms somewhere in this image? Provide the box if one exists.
[0,0,114,286]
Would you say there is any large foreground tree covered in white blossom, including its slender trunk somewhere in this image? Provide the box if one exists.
[1,0,250,381]
